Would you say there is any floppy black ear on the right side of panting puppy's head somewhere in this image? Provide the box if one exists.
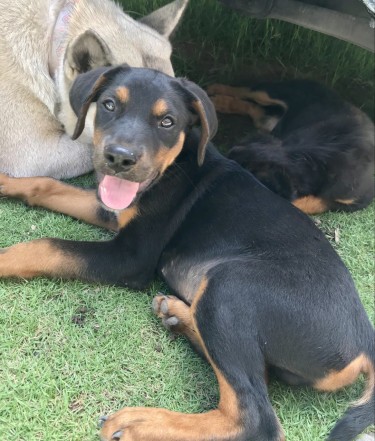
[178,79,218,165]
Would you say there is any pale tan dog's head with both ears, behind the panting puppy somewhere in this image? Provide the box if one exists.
[56,0,188,143]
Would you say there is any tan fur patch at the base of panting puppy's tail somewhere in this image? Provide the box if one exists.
[313,354,374,392]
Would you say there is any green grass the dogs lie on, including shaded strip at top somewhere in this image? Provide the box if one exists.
[0,0,375,441]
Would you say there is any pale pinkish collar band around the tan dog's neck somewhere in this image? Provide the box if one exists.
[48,0,79,79]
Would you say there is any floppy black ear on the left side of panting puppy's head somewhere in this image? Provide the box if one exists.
[69,65,130,139]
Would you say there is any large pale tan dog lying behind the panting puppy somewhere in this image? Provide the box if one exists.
[0,0,188,178]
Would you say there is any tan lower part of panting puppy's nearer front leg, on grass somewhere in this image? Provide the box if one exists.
[0,239,84,279]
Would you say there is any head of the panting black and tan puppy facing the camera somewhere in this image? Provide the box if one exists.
[70,66,217,210]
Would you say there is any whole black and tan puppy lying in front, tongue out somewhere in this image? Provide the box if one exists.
[0,67,375,441]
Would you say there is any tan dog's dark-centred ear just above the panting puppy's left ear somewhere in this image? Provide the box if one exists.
[64,30,113,81]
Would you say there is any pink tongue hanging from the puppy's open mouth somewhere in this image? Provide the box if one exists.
[99,175,139,210]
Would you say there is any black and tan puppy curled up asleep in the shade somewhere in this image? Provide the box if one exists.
[208,80,375,214]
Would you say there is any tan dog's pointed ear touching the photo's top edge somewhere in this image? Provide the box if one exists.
[139,0,189,38]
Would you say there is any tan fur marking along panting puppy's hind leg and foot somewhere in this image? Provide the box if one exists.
[101,278,242,441]
